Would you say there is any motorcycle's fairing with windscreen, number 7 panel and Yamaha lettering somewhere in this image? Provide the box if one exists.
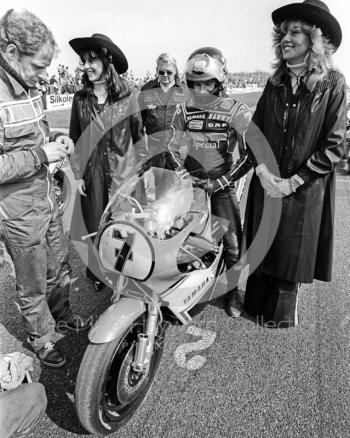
[96,169,226,322]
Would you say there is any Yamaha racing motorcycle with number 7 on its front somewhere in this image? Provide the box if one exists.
[75,168,242,435]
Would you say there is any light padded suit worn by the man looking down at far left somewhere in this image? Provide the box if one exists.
[0,57,72,351]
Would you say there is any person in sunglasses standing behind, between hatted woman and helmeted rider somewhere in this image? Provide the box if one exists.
[139,53,185,168]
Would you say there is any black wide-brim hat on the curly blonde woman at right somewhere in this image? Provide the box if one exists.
[272,0,342,49]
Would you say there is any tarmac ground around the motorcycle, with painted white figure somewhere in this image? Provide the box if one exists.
[0,165,350,438]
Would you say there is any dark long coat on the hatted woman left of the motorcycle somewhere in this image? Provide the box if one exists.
[69,90,148,238]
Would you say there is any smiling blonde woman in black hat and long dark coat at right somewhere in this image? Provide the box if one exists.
[244,0,346,327]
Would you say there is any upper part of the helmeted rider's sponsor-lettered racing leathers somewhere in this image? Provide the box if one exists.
[169,95,251,191]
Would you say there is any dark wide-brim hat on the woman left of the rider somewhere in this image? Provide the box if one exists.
[69,33,128,74]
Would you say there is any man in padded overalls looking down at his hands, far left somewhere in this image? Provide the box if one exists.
[0,9,87,368]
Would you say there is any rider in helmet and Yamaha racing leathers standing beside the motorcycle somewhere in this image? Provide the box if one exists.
[169,47,251,317]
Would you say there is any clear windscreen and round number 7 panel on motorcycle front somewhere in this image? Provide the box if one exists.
[96,168,196,281]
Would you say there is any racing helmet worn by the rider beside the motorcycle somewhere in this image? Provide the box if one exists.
[186,47,227,84]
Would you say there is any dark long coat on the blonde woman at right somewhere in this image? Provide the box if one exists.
[245,71,346,283]
